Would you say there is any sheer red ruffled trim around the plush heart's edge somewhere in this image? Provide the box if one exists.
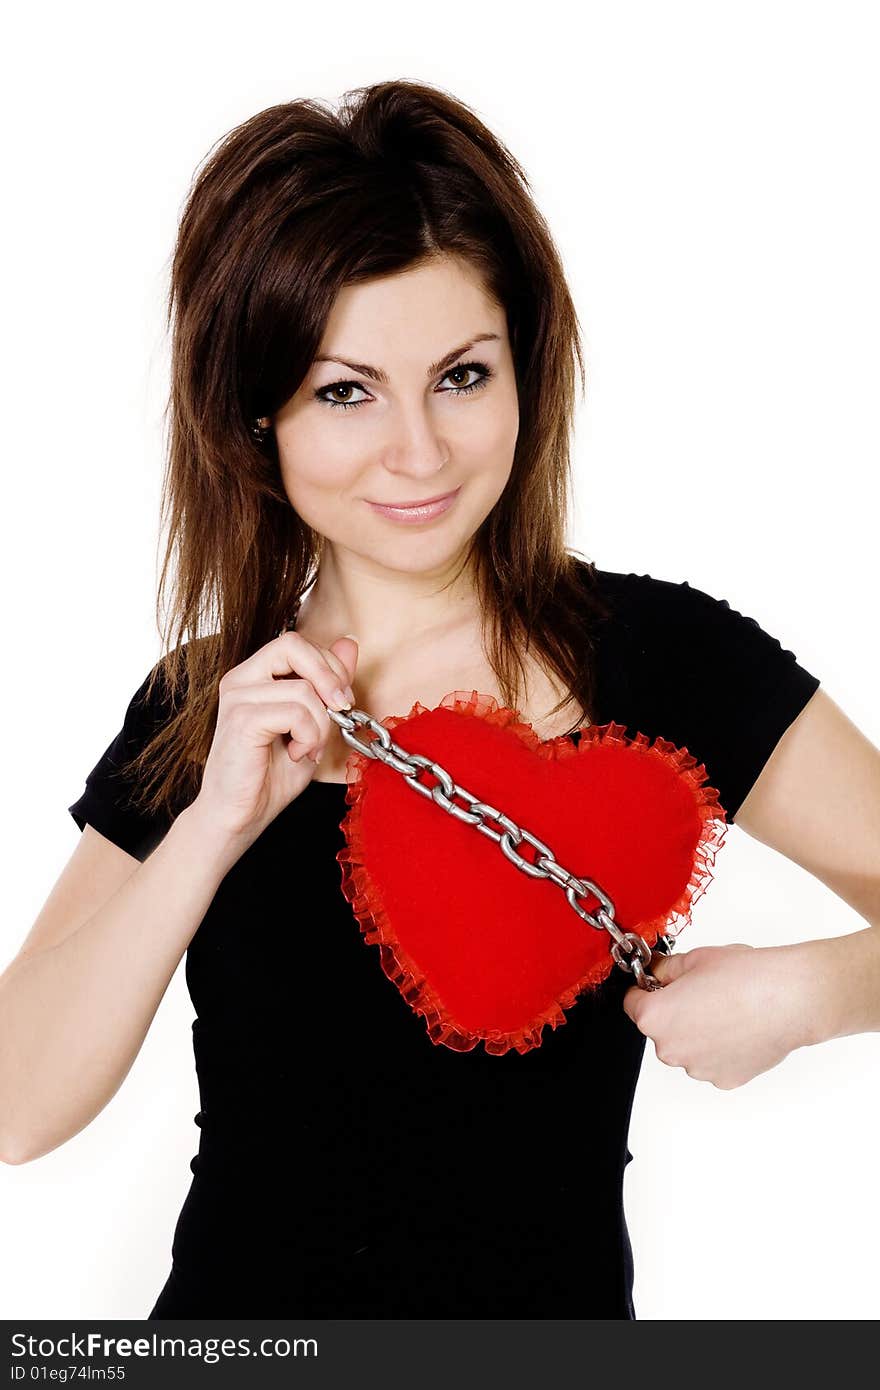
[336,691,728,1055]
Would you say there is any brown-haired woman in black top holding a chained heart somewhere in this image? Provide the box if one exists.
[3,82,880,1319]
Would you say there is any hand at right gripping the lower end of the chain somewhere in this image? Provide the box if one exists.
[623,942,805,1091]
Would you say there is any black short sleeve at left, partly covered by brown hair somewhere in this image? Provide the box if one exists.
[67,658,180,860]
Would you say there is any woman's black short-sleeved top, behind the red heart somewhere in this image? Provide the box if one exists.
[70,570,819,1318]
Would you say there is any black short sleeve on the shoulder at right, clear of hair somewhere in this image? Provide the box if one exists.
[611,574,819,821]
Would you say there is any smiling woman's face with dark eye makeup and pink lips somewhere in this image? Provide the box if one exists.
[272,259,519,573]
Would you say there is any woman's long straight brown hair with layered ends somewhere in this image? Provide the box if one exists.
[125,81,605,812]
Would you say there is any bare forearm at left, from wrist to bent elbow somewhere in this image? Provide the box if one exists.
[0,802,241,1163]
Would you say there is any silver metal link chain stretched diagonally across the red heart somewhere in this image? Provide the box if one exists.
[327,709,674,990]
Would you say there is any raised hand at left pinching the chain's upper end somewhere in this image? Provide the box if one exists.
[192,632,357,849]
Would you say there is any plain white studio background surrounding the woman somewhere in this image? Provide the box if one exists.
[0,0,880,1319]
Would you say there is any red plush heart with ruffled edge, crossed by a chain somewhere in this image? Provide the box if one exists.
[336,691,727,1054]
